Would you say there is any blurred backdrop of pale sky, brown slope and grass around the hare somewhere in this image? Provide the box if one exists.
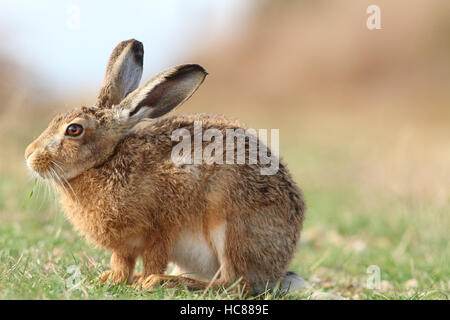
[0,0,450,298]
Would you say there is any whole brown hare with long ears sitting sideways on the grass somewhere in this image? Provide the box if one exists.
[25,39,305,293]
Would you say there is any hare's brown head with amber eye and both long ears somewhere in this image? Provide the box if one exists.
[25,39,207,180]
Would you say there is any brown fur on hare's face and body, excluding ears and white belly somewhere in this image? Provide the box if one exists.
[26,40,305,296]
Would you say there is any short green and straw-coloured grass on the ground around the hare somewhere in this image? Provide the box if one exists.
[0,106,450,299]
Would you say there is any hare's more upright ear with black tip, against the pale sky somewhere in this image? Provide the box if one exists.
[96,39,144,108]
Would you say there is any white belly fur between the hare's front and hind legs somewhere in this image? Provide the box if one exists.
[171,223,225,280]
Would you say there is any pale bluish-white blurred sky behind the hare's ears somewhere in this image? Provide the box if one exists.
[0,0,254,91]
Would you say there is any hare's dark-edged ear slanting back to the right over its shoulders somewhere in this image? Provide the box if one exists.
[119,64,207,122]
